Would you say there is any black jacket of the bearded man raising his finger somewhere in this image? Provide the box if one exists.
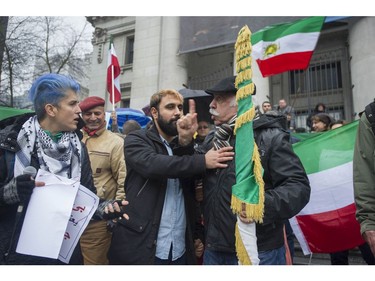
[108,123,205,265]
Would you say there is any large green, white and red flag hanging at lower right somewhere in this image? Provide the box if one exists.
[289,121,364,255]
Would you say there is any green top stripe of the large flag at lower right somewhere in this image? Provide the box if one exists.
[293,120,358,174]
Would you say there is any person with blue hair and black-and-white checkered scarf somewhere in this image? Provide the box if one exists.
[0,73,127,265]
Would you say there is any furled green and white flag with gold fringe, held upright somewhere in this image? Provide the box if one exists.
[231,25,264,265]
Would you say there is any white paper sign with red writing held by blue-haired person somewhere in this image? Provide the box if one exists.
[16,170,99,263]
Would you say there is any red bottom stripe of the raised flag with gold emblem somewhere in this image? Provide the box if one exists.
[256,51,313,77]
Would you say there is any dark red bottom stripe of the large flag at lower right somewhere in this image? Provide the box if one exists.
[296,203,365,253]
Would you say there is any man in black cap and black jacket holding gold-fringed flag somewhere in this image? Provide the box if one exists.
[197,76,310,265]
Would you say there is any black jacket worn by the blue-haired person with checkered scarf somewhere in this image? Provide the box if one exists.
[0,113,96,265]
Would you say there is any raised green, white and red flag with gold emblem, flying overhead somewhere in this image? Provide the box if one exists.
[251,17,325,77]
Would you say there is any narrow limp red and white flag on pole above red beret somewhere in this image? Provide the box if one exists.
[107,38,121,104]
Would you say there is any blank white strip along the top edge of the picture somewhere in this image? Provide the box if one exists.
[0,0,368,16]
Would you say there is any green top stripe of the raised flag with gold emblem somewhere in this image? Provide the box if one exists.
[251,17,325,45]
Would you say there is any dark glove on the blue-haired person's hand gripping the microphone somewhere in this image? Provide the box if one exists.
[0,175,35,205]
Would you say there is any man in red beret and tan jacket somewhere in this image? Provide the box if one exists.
[79,96,126,265]
